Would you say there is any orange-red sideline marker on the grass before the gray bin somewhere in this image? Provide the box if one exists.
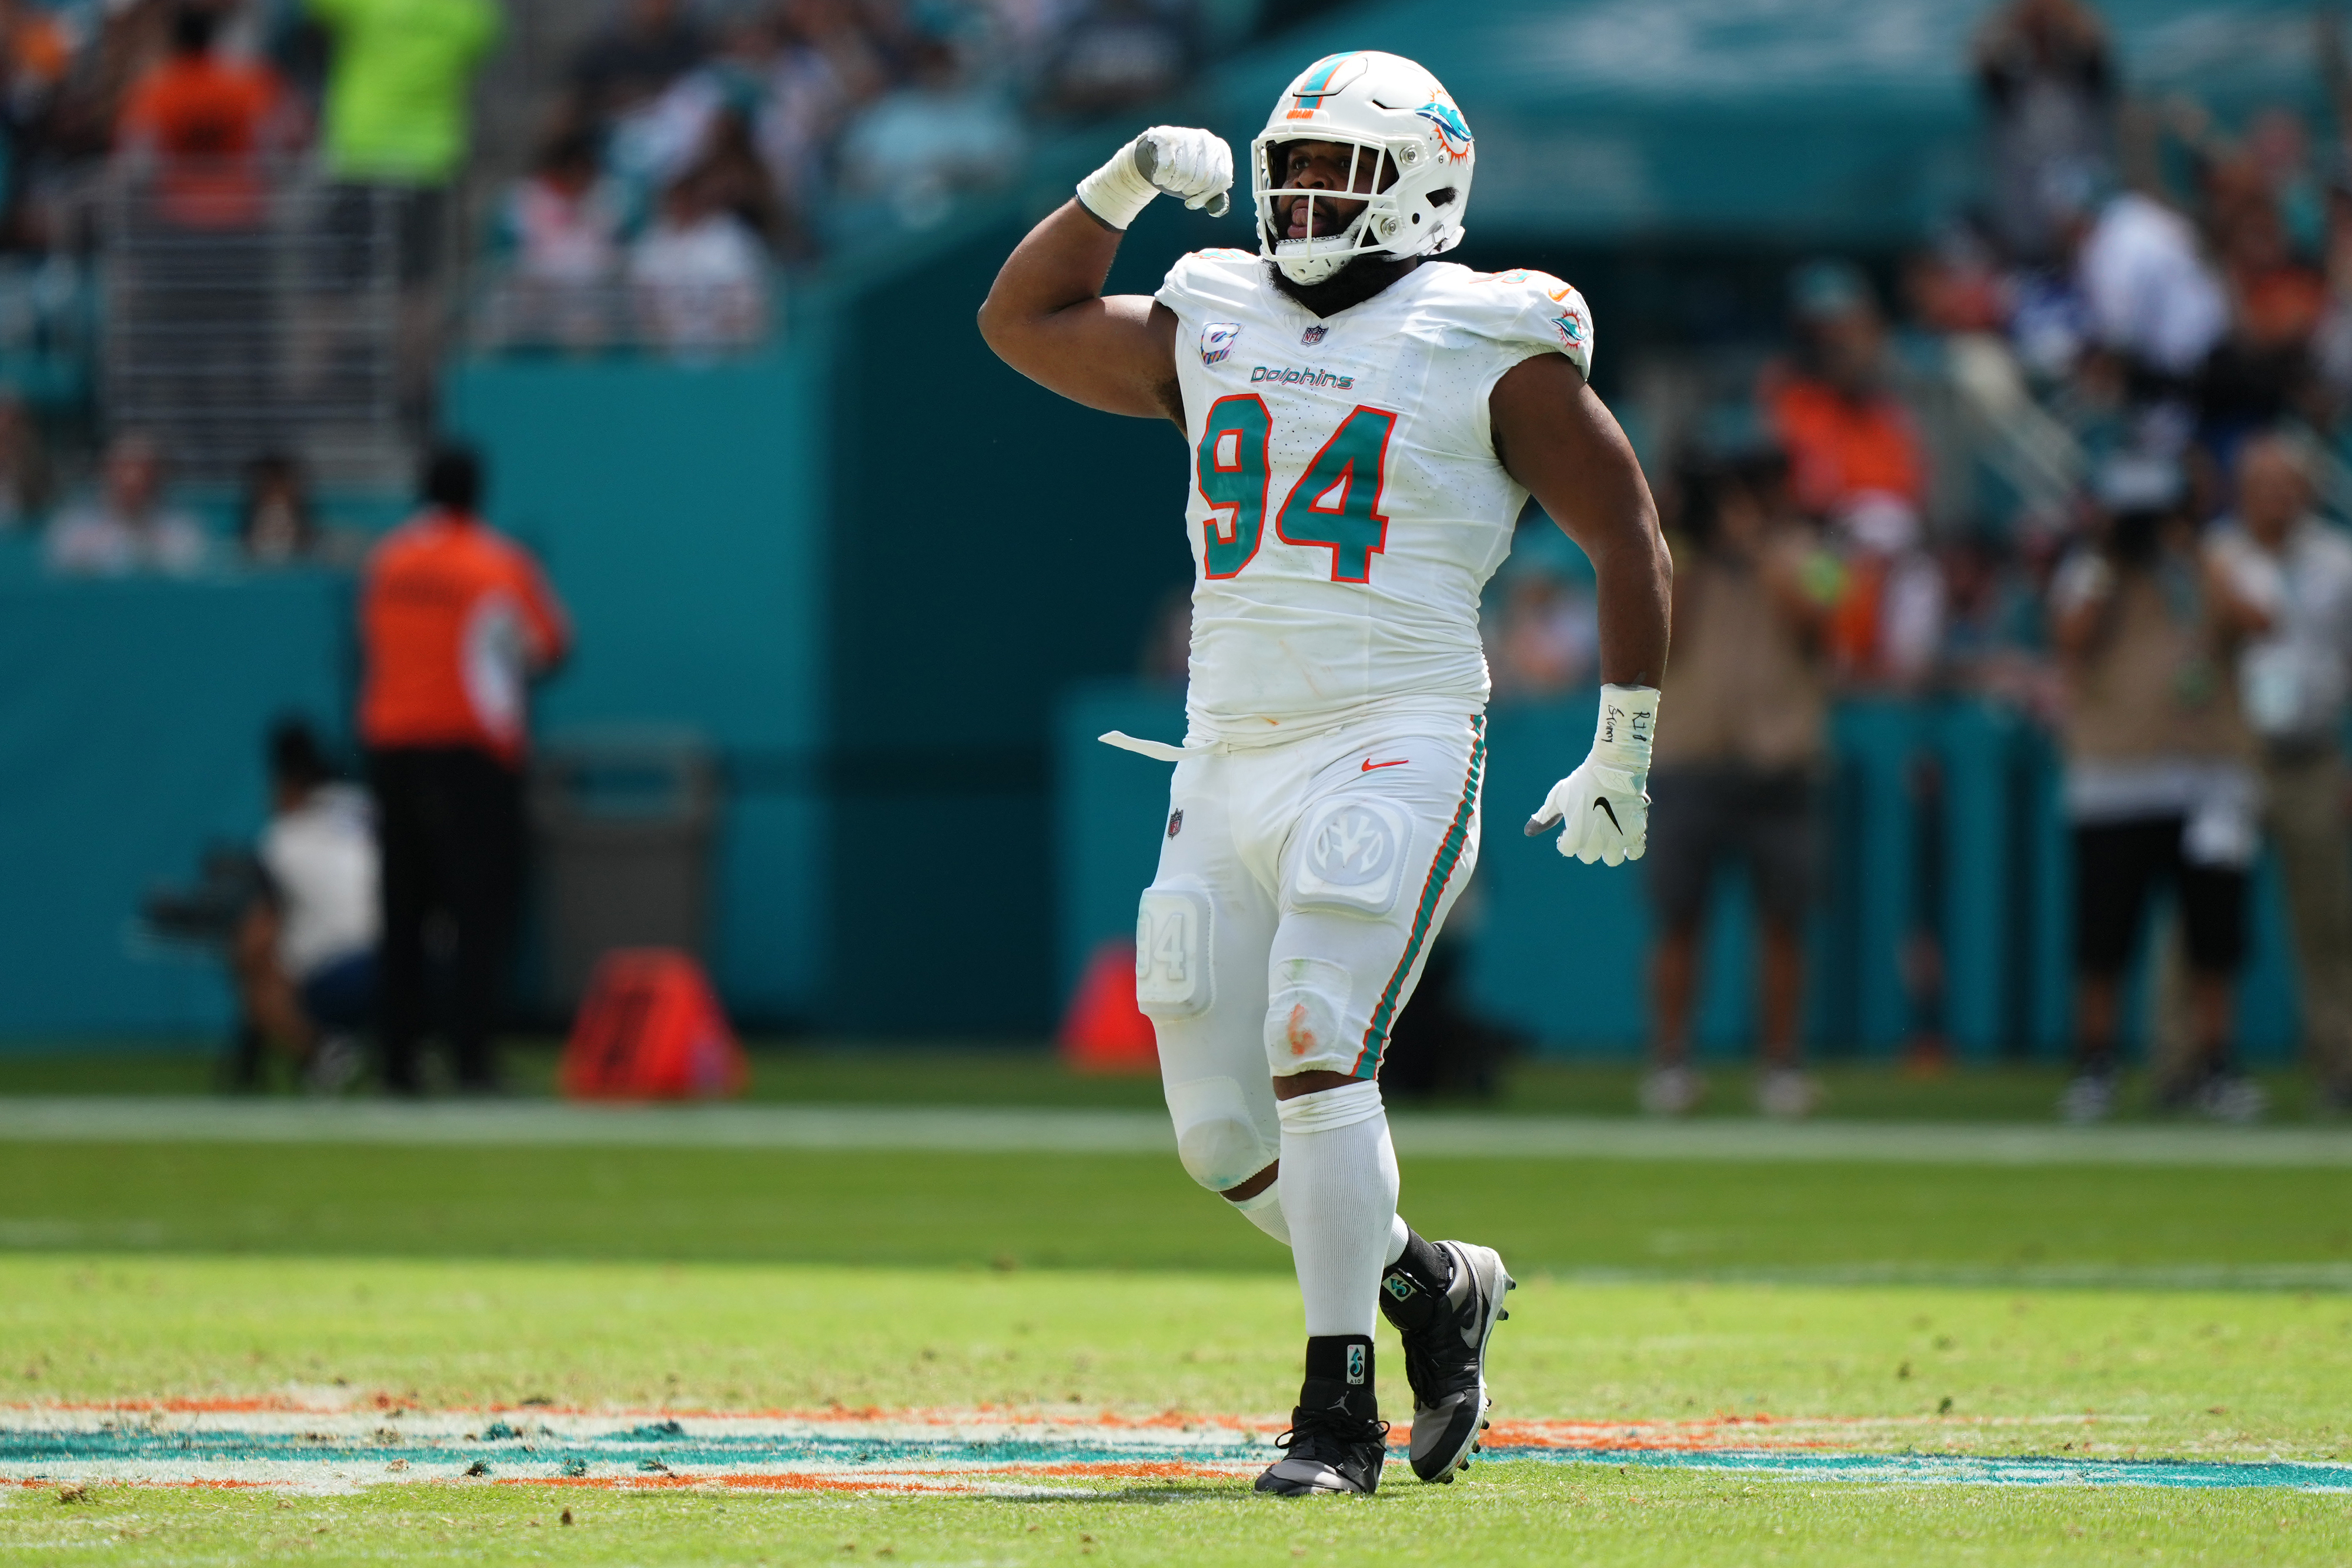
[560,947,750,1100]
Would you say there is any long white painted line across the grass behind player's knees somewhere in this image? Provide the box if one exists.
[0,1098,2352,1168]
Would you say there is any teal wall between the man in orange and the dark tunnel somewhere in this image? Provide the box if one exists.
[445,310,833,1025]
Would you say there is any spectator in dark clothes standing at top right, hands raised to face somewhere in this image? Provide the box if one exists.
[1976,0,2117,266]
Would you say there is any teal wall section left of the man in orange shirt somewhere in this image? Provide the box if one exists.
[0,566,353,1046]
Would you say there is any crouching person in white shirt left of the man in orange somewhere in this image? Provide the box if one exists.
[230,722,379,1093]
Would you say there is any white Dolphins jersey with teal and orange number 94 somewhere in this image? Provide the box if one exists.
[1157,249,1592,745]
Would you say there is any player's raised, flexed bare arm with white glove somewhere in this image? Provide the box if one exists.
[981,125,1232,426]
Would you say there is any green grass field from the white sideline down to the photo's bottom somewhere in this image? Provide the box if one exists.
[0,1055,2352,1566]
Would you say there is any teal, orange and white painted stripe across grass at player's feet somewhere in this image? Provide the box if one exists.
[0,1422,2352,1493]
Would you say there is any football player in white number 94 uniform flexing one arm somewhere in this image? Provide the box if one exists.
[981,52,1670,1495]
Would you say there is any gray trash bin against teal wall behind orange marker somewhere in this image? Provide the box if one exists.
[532,731,720,1015]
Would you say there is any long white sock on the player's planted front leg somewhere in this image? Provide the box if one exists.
[1289,1081,1404,1338]
